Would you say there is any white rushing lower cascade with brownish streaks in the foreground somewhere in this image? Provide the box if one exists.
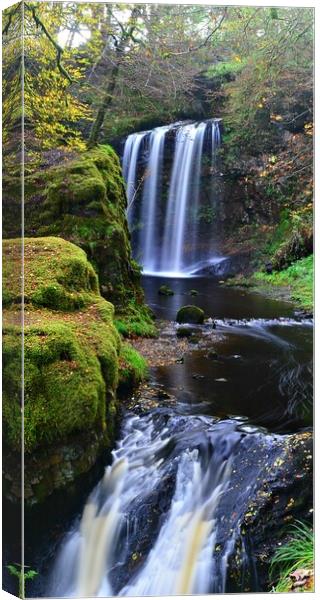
[47,408,277,597]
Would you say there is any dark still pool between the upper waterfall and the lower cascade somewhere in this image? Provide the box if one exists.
[144,277,313,432]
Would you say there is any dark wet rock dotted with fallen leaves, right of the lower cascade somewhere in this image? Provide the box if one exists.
[222,432,313,592]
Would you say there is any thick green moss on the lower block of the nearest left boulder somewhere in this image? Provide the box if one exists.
[4,313,120,452]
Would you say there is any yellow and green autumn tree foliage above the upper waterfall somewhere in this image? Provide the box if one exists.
[4,2,313,152]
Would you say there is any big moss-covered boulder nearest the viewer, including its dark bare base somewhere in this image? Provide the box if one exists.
[3,237,121,504]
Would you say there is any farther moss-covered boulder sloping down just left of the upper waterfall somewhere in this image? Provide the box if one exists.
[3,146,155,335]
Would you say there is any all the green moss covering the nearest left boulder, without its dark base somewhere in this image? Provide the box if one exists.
[3,238,121,453]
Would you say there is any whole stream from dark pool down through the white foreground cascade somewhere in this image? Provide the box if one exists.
[26,277,313,597]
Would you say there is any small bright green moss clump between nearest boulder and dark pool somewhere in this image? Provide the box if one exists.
[119,344,148,393]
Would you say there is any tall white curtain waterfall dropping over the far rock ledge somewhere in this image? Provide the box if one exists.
[123,121,220,276]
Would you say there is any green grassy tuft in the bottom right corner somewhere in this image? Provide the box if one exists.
[270,521,314,592]
